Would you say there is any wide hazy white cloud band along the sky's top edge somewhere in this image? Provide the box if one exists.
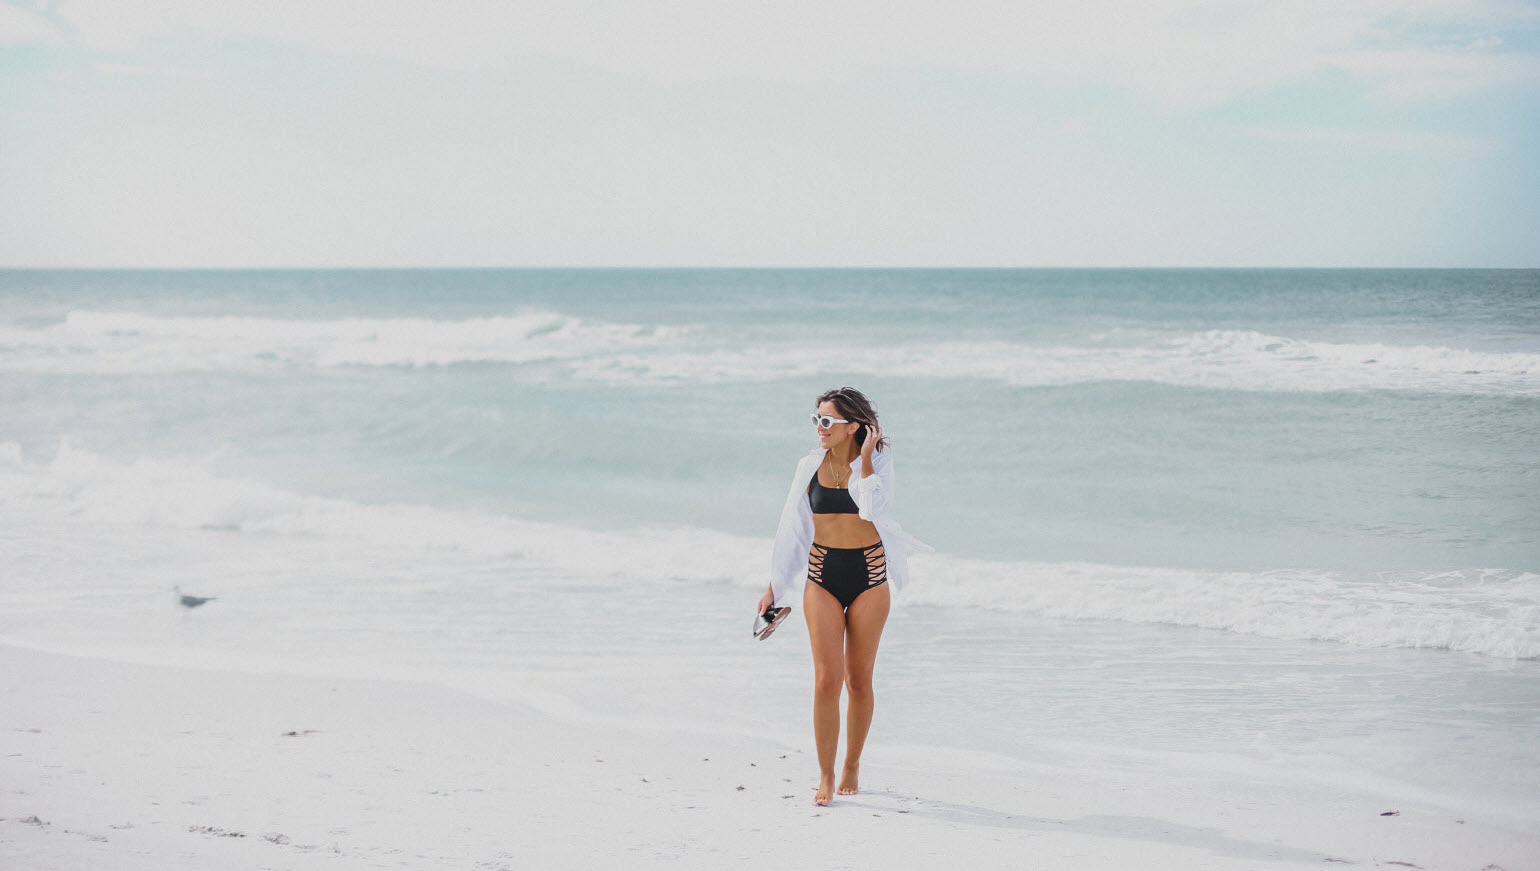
[21,0,1537,106]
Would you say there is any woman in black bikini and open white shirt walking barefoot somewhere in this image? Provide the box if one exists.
[759,388,926,805]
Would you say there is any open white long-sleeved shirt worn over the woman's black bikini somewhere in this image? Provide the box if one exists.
[770,448,932,605]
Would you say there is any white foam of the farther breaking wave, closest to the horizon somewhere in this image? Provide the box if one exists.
[0,311,1540,395]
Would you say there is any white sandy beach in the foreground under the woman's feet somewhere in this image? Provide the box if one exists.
[0,645,1540,871]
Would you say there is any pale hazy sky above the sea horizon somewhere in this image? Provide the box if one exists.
[0,0,1540,268]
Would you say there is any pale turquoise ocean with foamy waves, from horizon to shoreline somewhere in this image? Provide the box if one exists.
[0,269,1540,825]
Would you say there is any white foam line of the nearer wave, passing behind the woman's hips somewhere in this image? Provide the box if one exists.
[0,445,1540,659]
